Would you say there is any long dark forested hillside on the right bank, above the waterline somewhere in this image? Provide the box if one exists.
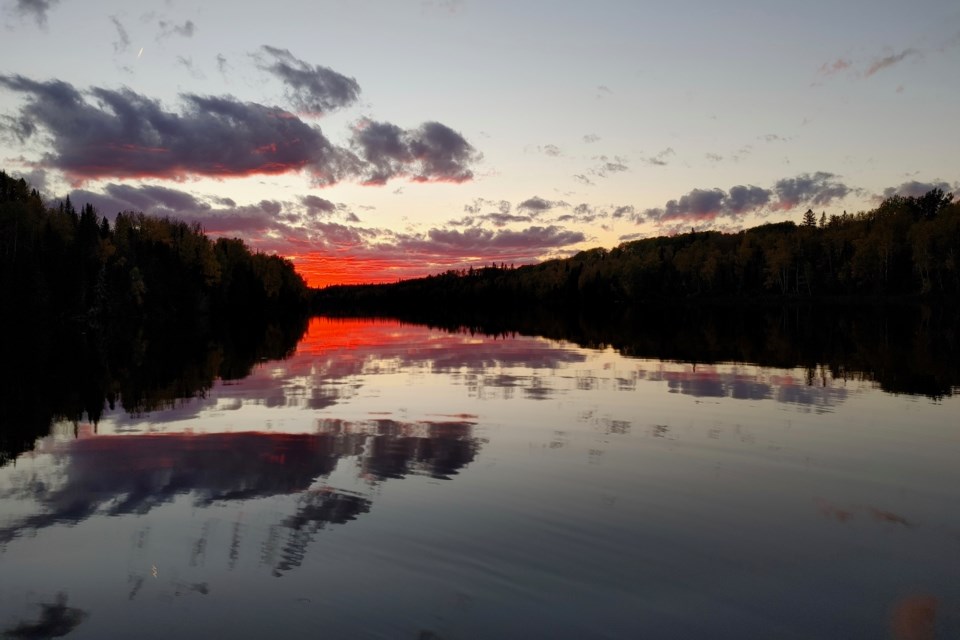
[314,189,960,313]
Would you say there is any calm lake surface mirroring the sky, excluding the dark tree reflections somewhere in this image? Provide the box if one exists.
[0,319,960,640]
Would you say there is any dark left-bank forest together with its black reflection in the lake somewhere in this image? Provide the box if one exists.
[0,171,309,462]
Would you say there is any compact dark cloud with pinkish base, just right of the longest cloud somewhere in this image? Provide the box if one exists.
[351,120,482,185]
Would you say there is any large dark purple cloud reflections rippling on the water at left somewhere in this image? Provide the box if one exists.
[0,419,480,580]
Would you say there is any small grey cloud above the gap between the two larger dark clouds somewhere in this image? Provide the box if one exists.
[255,45,360,114]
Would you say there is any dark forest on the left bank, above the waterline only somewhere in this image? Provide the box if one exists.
[0,171,308,330]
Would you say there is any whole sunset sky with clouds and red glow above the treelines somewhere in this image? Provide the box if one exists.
[0,0,960,286]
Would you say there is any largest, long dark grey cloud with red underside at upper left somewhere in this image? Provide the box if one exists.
[0,75,357,184]
